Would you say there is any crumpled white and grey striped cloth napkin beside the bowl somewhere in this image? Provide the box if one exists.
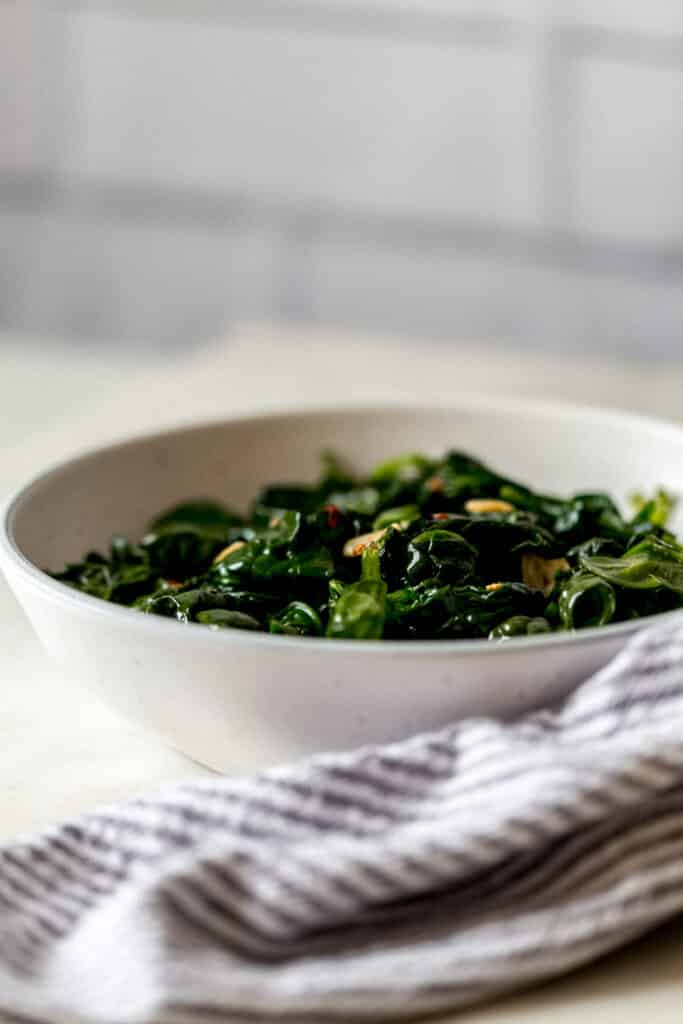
[0,625,683,1024]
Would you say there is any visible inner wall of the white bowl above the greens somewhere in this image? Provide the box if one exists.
[10,399,683,569]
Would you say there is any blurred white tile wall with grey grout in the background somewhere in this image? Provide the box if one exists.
[0,0,683,358]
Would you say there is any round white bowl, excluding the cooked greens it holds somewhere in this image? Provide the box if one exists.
[0,397,683,770]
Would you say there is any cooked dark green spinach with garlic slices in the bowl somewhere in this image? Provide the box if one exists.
[54,452,683,640]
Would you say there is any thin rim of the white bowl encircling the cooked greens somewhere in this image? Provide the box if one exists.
[0,392,683,657]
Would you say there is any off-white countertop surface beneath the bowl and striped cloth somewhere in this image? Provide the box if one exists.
[0,325,683,1024]
